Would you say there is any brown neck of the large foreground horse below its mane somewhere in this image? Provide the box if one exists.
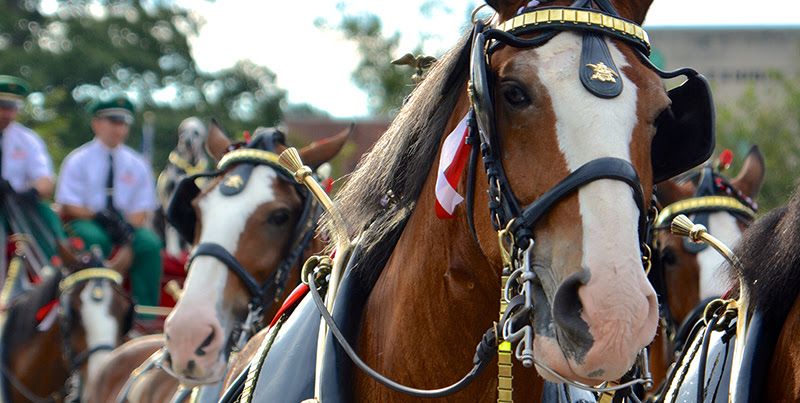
[355,103,541,401]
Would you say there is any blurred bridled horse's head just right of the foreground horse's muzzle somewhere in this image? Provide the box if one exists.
[651,146,765,330]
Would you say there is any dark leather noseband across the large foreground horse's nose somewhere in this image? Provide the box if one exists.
[509,157,647,246]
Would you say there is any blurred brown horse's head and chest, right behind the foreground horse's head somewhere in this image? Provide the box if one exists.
[648,146,766,385]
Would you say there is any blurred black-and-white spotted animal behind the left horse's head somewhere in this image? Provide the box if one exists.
[155,117,208,258]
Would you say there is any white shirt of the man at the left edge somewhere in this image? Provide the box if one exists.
[2,122,55,192]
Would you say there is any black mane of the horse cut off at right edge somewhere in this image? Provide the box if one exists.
[734,186,800,323]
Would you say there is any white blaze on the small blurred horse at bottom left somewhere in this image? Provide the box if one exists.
[75,280,119,396]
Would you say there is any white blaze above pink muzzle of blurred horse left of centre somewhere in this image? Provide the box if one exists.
[173,166,277,337]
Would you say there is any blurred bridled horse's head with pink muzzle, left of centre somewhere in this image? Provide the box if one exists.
[165,120,349,383]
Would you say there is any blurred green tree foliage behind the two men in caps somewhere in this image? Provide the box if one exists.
[0,0,286,169]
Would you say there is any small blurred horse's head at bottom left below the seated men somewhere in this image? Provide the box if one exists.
[54,244,134,398]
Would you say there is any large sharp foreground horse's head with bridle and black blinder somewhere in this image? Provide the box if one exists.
[470,0,714,383]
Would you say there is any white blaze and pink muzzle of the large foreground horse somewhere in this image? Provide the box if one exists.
[535,32,658,379]
